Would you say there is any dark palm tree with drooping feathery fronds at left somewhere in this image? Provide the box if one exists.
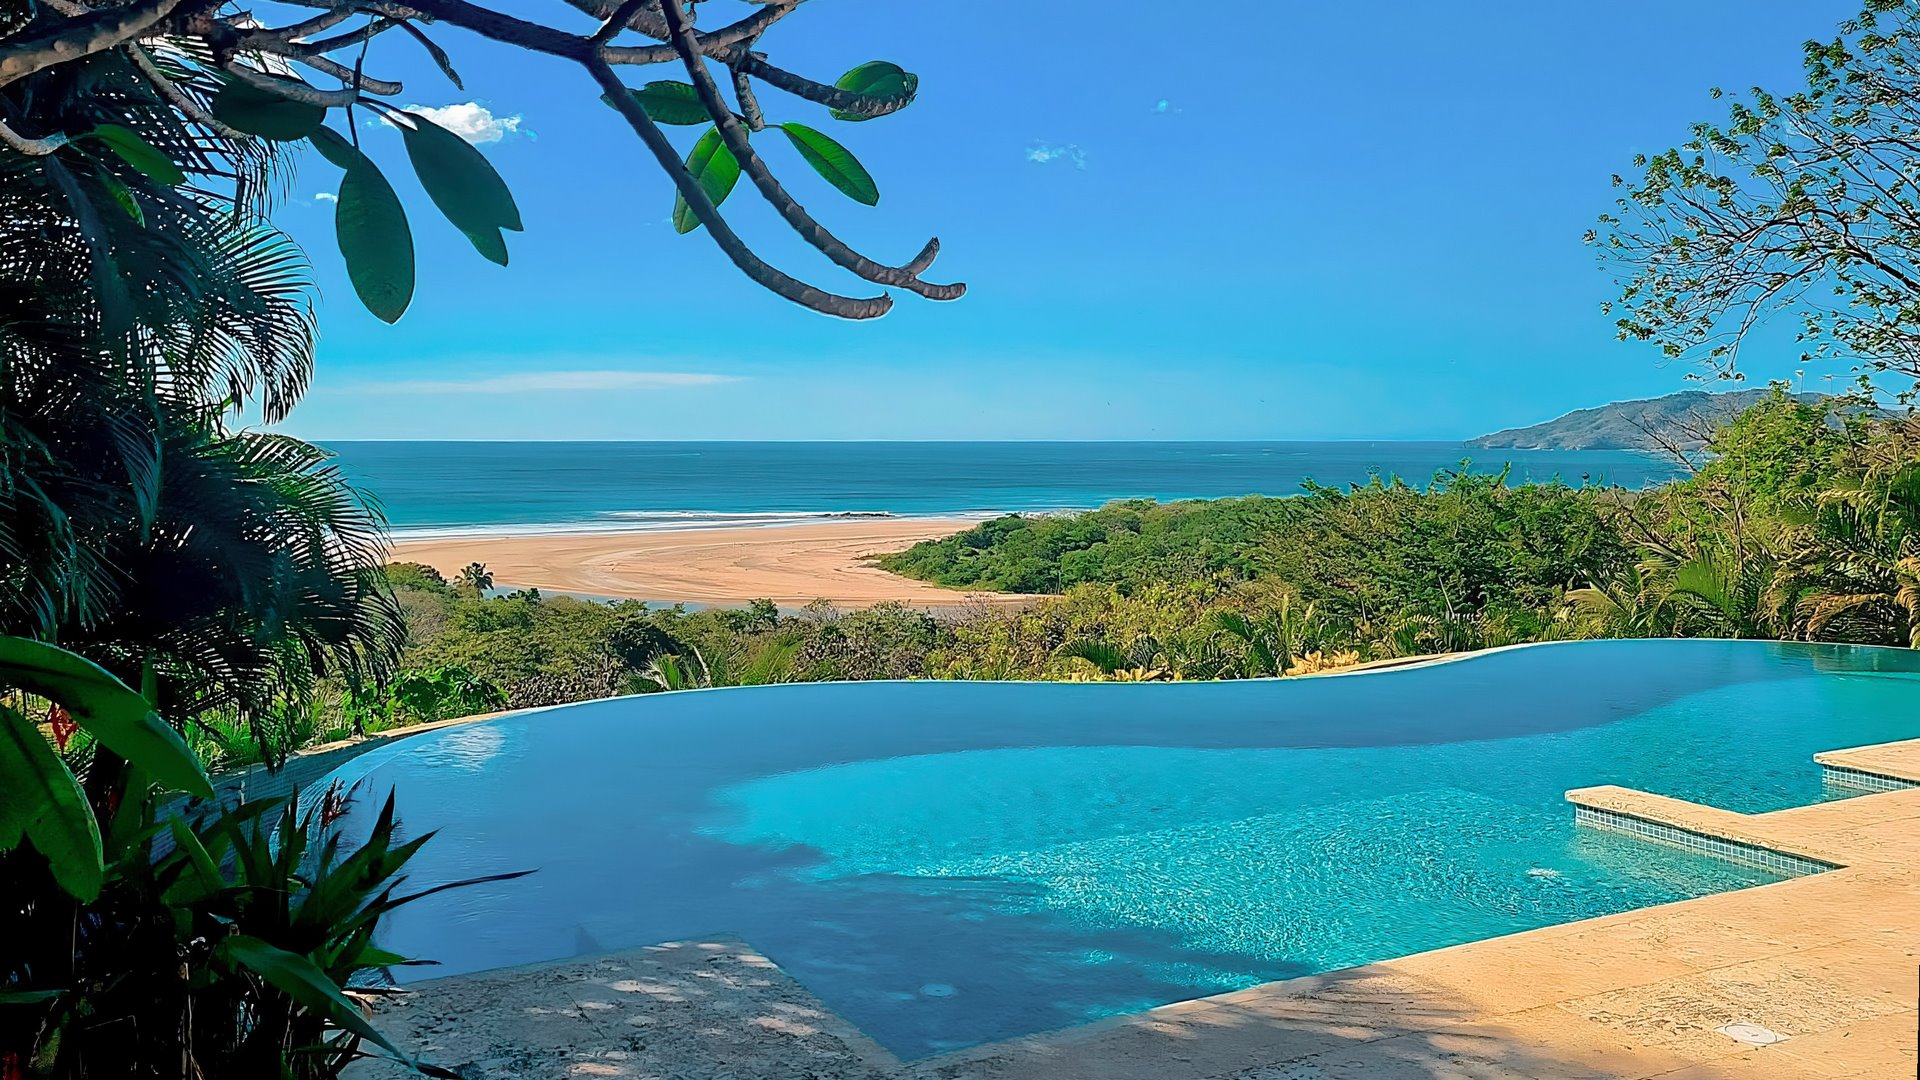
[0,37,399,760]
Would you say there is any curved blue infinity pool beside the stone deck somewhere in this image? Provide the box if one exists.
[340,642,1920,1057]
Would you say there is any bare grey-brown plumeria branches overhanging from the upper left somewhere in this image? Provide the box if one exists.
[0,0,966,319]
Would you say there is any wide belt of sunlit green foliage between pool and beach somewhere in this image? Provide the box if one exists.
[349,392,1920,703]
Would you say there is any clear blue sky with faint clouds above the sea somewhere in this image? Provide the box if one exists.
[278,0,1857,440]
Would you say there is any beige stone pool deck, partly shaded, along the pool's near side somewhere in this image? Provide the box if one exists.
[349,740,1920,1080]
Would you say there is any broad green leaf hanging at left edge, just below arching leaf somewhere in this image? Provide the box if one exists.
[0,705,106,901]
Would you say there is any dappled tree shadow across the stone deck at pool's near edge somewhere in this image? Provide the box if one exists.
[351,938,1665,1080]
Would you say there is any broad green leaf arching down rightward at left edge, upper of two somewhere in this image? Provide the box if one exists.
[0,638,213,798]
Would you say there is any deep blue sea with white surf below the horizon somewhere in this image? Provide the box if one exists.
[328,442,1676,538]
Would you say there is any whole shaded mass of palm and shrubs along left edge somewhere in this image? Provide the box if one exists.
[0,18,480,1078]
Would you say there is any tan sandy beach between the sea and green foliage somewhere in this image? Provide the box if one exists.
[392,519,1031,607]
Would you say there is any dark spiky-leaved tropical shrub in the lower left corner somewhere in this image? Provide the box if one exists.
[0,638,518,1078]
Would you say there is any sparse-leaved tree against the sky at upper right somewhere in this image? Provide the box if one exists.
[1588,0,1920,395]
